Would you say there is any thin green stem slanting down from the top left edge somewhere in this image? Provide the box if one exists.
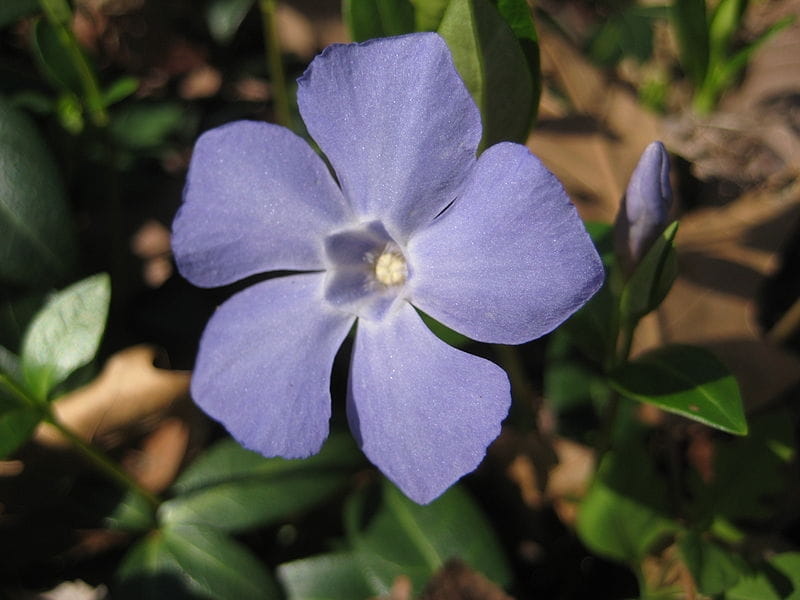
[39,0,109,127]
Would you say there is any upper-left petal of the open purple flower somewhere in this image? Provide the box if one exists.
[172,121,350,287]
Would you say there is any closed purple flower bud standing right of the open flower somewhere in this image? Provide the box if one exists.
[615,142,672,269]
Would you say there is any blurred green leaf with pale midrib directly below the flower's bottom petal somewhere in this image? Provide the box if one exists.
[346,482,510,595]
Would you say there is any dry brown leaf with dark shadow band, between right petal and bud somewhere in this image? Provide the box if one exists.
[528,30,661,222]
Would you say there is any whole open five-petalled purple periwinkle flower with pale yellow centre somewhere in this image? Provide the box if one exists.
[172,33,603,503]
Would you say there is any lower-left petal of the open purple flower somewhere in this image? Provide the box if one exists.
[191,273,354,458]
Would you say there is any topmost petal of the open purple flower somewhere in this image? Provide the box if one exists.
[297,33,481,243]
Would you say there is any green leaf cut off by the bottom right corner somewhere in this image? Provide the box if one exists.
[725,552,800,600]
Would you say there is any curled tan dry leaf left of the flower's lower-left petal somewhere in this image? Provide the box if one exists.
[35,346,190,446]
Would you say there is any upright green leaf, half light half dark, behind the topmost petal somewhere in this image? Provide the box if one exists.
[439,0,536,148]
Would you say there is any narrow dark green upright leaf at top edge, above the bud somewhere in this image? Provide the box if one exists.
[672,0,709,87]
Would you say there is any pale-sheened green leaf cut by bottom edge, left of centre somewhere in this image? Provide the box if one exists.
[278,552,375,600]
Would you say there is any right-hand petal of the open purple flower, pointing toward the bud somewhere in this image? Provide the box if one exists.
[407,143,604,344]
